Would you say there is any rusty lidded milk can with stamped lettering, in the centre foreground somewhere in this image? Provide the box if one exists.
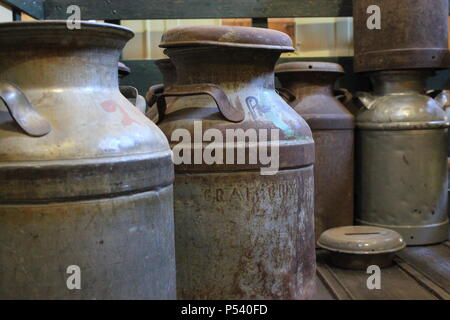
[158,26,315,299]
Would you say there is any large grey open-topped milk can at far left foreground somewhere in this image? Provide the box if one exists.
[0,21,176,299]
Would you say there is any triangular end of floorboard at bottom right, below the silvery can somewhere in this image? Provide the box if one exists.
[398,245,450,293]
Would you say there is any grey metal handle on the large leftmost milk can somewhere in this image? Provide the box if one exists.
[0,81,52,137]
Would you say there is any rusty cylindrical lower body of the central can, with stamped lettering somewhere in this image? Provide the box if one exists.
[175,167,315,299]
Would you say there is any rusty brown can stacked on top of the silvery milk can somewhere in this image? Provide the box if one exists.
[353,0,450,72]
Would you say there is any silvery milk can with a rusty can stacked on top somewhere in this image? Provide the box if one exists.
[356,71,448,245]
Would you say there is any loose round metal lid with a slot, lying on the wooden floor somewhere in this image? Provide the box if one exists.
[317,226,406,254]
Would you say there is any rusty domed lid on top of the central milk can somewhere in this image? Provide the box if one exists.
[159,26,294,52]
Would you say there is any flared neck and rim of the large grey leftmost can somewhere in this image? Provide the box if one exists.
[0,21,133,92]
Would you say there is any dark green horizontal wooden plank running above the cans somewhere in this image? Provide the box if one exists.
[45,0,352,20]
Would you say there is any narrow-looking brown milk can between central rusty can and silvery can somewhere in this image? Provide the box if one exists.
[275,62,355,241]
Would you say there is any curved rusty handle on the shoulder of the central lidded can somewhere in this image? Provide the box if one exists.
[157,83,245,122]
